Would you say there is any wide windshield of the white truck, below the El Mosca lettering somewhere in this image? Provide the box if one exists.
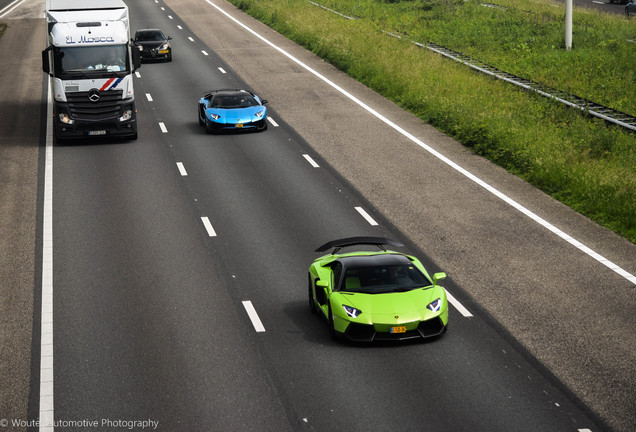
[55,45,130,75]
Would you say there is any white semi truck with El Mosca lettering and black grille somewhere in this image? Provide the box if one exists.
[42,0,141,140]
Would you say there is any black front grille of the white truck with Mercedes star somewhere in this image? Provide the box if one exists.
[66,90,123,120]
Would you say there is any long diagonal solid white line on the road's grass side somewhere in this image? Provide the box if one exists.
[205,0,636,285]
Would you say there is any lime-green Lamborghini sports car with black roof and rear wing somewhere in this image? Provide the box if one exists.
[308,237,448,342]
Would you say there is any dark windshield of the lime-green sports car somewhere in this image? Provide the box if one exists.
[340,264,431,294]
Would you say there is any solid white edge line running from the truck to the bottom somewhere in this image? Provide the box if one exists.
[39,81,55,432]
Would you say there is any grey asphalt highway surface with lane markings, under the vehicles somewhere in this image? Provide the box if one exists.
[0,0,636,432]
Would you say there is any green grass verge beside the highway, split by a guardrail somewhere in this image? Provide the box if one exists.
[230,0,636,242]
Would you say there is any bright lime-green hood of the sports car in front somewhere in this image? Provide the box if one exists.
[335,286,447,323]
